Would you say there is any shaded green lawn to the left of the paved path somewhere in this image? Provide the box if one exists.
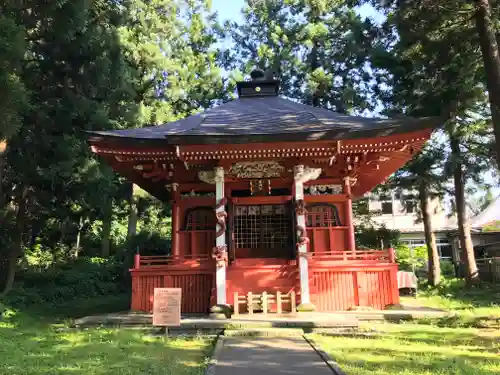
[0,314,212,375]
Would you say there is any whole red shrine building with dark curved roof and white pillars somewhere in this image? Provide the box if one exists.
[89,71,438,313]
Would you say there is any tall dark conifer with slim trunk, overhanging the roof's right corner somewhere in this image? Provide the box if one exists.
[368,0,492,282]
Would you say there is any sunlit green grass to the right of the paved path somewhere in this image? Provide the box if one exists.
[311,324,500,375]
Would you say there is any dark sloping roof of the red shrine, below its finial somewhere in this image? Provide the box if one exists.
[87,96,441,144]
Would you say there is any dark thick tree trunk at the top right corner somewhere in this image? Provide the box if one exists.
[474,0,500,168]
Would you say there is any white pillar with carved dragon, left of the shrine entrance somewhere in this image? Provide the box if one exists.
[215,167,227,305]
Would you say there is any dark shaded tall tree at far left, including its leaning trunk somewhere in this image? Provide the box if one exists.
[0,0,133,292]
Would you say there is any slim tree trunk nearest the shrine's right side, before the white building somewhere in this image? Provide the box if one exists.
[419,183,441,286]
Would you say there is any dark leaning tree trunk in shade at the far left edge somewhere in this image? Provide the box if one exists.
[0,188,28,295]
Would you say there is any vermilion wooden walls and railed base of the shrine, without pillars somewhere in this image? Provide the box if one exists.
[131,191,399,313]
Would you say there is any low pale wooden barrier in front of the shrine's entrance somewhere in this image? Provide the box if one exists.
[233,290,297,316]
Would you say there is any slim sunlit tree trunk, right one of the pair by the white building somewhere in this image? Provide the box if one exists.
[450,134,479,284]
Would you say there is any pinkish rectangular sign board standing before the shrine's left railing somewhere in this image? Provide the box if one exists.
[153,288,181,327]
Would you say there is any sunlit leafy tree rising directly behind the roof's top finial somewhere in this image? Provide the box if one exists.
[228,0,376,113]
